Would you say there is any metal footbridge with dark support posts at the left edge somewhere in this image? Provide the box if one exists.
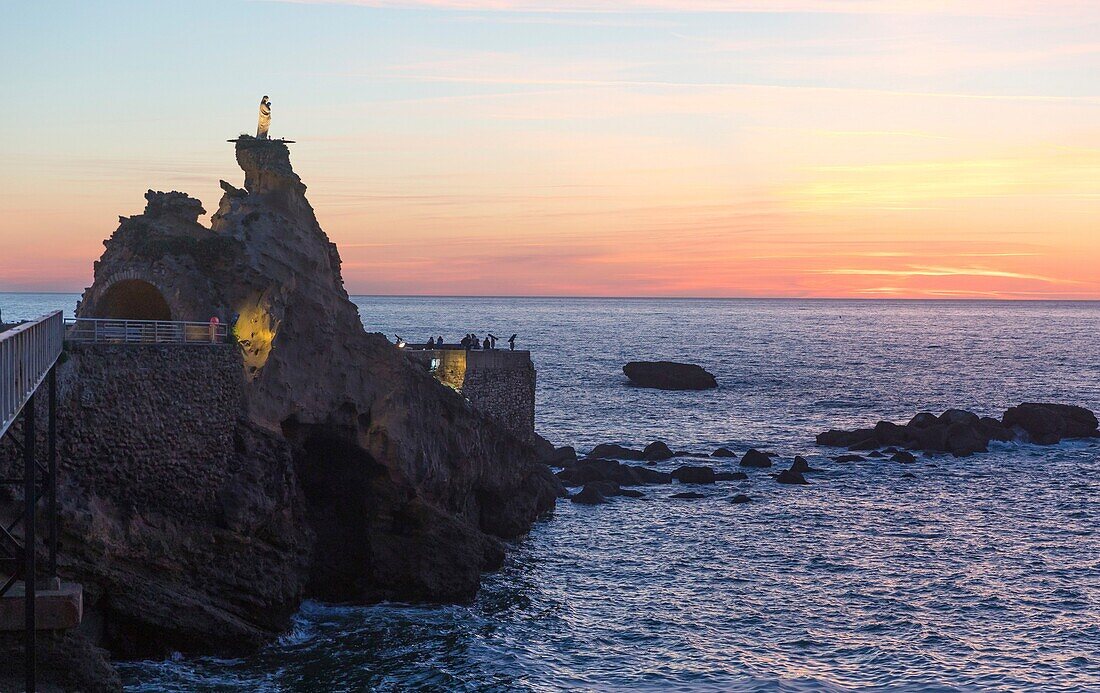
[0,310,84,691]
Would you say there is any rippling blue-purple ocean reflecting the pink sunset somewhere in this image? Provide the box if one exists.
[0,294,1100,692]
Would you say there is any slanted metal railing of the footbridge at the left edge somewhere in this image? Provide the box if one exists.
[0,310,65,436]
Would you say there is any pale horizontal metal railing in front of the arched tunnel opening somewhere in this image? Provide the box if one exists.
[65,318,229,344]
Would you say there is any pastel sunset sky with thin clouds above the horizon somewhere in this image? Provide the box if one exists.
[0,0,1100,299]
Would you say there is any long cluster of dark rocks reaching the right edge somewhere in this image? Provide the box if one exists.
[817,403,1100,461]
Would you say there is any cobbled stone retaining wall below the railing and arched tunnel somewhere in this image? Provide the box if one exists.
[58,343,243,517]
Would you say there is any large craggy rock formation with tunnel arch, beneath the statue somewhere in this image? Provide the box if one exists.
[2,136,560,690]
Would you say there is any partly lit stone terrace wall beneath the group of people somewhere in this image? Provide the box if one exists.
[406,349,536,442]
